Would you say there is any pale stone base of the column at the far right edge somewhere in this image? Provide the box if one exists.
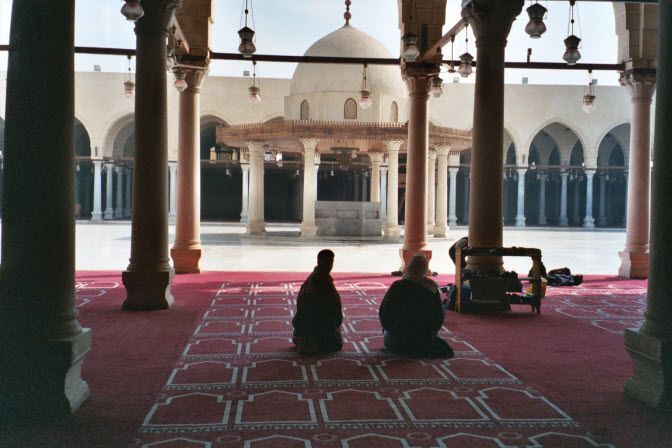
[624,329,672,412]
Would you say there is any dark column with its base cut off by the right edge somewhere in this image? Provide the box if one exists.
[624,0,672,412]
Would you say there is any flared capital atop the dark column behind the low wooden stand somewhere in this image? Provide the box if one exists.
[462,0,525,47]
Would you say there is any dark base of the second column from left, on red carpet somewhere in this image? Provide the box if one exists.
[121,269,175,311]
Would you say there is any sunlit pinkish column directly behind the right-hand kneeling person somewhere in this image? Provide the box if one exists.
[400,73,432,271]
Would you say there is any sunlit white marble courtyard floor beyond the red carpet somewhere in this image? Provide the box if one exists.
[42,222,625,275]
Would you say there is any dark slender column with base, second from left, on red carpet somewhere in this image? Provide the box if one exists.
[122,0,180,310]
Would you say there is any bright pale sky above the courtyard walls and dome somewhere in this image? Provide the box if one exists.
[0,0,618,85]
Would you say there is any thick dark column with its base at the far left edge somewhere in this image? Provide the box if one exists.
[0,0,90,420]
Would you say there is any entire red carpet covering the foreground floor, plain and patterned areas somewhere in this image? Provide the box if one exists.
[2,272,672,448]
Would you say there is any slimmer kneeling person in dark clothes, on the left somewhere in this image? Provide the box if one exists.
[292,249,343,356]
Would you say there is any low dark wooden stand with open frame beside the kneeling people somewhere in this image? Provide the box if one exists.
[455,247,543,314]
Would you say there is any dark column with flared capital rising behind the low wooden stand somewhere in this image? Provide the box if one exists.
[462,0,524,270]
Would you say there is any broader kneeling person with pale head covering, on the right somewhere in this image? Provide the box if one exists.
[378,254,455,358]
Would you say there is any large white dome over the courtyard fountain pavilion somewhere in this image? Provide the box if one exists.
[289,25,405,101]
